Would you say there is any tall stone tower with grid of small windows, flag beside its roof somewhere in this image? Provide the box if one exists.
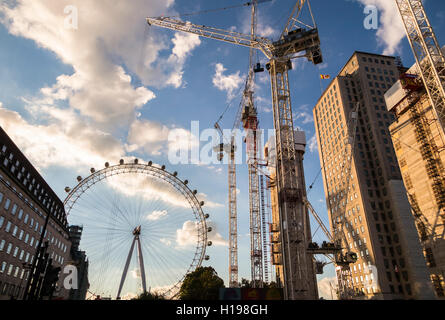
[313,52,434,299]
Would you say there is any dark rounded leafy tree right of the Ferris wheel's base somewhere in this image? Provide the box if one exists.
[179,267,224,300]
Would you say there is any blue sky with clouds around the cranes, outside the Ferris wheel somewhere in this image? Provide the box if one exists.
[0,0,445,296]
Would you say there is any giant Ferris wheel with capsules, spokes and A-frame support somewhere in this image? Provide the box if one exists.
[64,160,212,299]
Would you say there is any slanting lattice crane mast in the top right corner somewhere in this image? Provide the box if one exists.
[396,0,445,132]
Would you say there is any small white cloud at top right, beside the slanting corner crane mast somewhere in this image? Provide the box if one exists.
[358,0,406,55]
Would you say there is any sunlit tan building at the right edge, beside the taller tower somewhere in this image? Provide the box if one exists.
[385,48,445,299]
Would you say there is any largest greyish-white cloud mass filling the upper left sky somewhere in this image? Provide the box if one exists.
[0,0,200,128]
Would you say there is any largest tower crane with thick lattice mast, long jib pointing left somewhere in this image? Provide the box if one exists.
[147,0,323,300]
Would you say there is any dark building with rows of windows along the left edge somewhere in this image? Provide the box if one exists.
[0,127,71,300]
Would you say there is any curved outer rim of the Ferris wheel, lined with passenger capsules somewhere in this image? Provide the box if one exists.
[63,160,208,299]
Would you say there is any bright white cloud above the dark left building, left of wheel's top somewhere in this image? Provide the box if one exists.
[0,104,124,168]
